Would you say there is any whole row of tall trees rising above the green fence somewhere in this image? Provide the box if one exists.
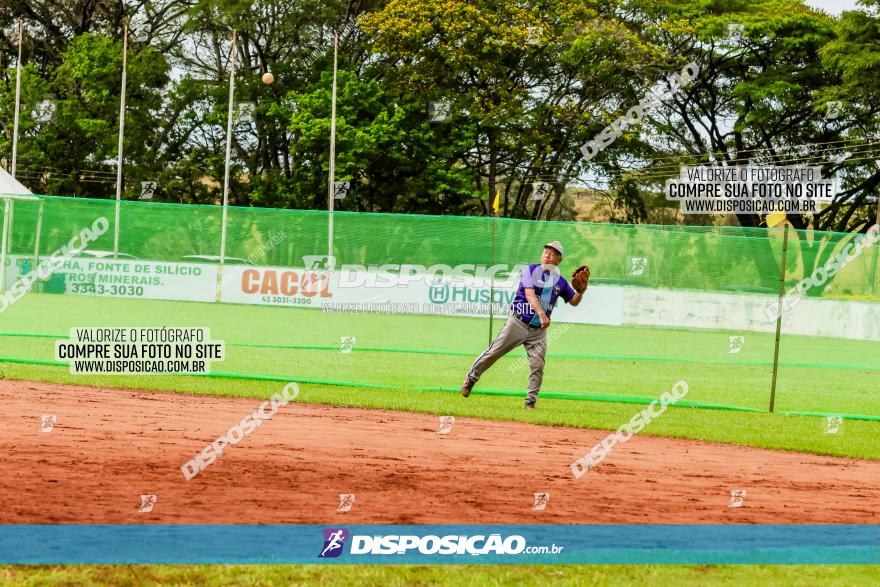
[0,0,880,231]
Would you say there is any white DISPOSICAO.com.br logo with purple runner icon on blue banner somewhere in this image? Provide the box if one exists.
[318,528,564,558]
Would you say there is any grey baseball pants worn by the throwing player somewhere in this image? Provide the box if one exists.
[468,316,547,404]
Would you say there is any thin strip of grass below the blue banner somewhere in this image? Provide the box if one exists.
[6,565,877,587]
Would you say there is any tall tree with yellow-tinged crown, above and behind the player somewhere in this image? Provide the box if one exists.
[361,0,655,218]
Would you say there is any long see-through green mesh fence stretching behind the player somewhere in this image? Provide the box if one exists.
[0,196,880,420]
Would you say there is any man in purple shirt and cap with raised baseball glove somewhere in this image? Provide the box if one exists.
[461,241,590,410]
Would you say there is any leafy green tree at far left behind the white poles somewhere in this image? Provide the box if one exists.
[0,33,169,197]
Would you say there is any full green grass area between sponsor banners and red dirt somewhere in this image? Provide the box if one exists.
[0,294,880,459]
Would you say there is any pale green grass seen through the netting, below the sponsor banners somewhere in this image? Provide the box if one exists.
[0,294,880,417]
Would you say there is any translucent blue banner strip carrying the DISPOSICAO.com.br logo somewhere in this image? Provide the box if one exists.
[0,524,880,564]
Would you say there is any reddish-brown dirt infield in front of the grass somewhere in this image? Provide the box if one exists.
[0,381,880,524]
